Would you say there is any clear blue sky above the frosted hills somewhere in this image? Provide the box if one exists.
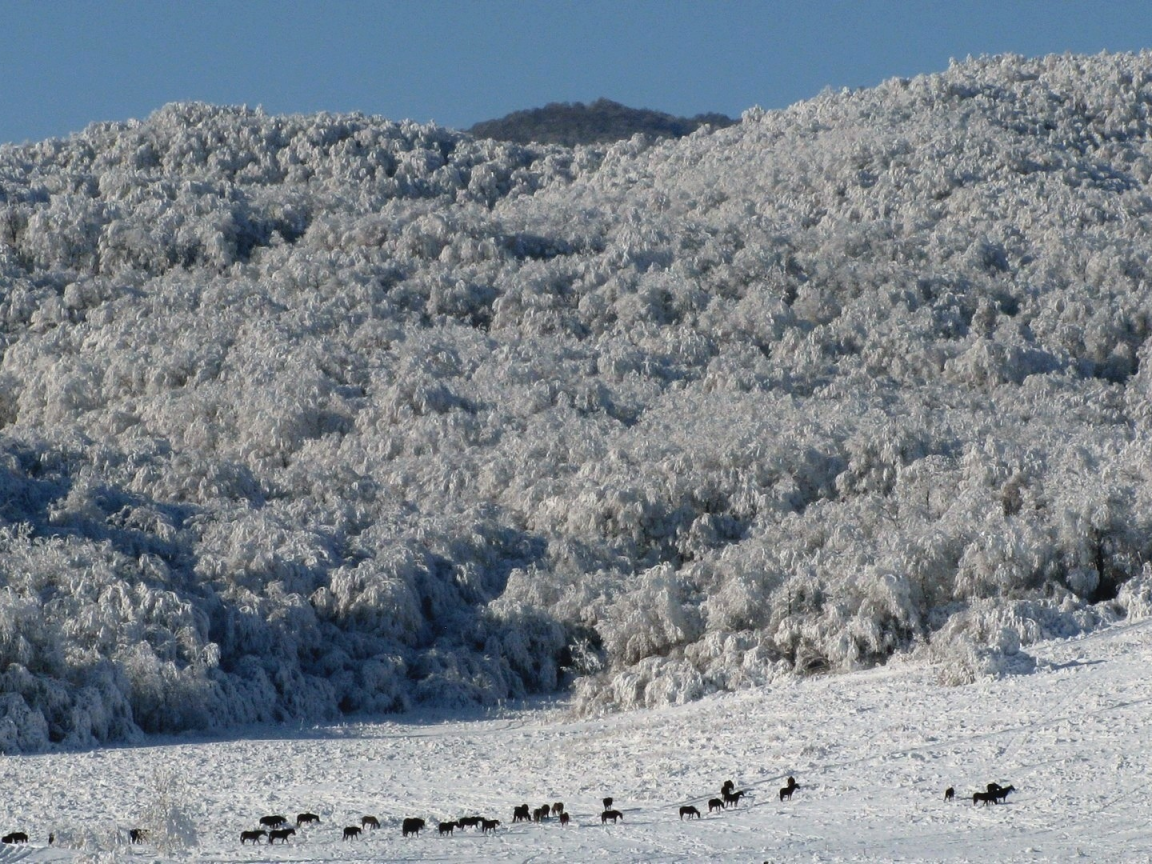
[0,0,1152,142]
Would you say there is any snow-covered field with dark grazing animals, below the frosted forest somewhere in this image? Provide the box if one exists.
[0,621,1152,862]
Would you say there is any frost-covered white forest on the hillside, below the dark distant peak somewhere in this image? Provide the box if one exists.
[0,53,1152,752]
